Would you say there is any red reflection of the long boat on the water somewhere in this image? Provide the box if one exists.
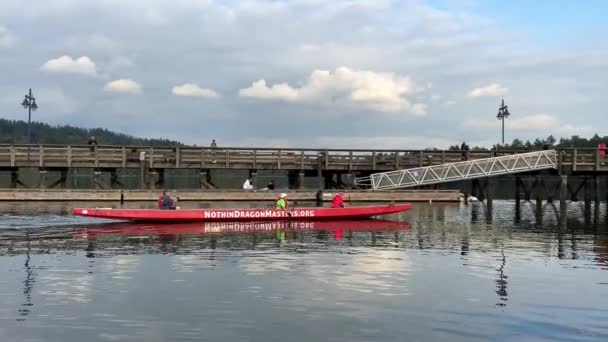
[74,220,412,237]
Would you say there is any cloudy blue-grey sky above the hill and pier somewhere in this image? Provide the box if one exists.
[0,0,608,149]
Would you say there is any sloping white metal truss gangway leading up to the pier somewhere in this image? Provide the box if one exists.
[355,150,557,190]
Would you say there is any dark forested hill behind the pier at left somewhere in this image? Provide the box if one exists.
[0,119,183,146]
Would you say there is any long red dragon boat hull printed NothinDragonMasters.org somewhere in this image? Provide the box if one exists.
[72,204,412,222]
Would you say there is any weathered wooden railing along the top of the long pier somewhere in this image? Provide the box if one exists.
[0,145,608,171]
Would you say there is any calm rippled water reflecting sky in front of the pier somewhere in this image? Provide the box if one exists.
[0,201,608,342]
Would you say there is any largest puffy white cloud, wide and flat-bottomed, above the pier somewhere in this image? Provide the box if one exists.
[239,67,426,115]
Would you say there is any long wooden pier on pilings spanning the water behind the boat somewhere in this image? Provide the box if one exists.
[0,145,608,205]
